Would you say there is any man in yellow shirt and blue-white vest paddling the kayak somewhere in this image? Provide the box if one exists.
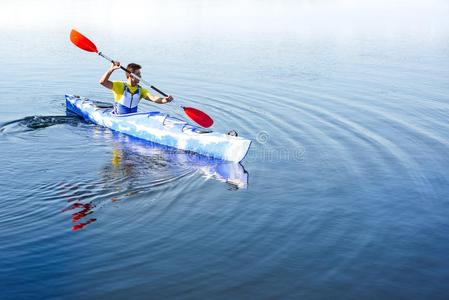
[100,61,173,114]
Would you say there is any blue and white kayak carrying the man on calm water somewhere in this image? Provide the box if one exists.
[65,95,251,162]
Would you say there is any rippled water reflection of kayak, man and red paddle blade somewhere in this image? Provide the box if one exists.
[63,126,248,231]
